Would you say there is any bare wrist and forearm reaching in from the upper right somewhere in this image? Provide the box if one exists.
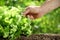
[40,0,60,14]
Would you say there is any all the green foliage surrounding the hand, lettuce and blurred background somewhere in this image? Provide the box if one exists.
[0,0,60,40]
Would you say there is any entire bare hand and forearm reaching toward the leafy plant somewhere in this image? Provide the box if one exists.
[24,0,60,19]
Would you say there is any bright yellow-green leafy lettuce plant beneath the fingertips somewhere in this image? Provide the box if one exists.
[0,6,32,40]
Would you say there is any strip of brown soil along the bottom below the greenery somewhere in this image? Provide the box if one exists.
[17,34,60,40]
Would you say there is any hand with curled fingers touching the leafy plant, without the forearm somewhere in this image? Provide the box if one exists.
[24,6,42,19]
